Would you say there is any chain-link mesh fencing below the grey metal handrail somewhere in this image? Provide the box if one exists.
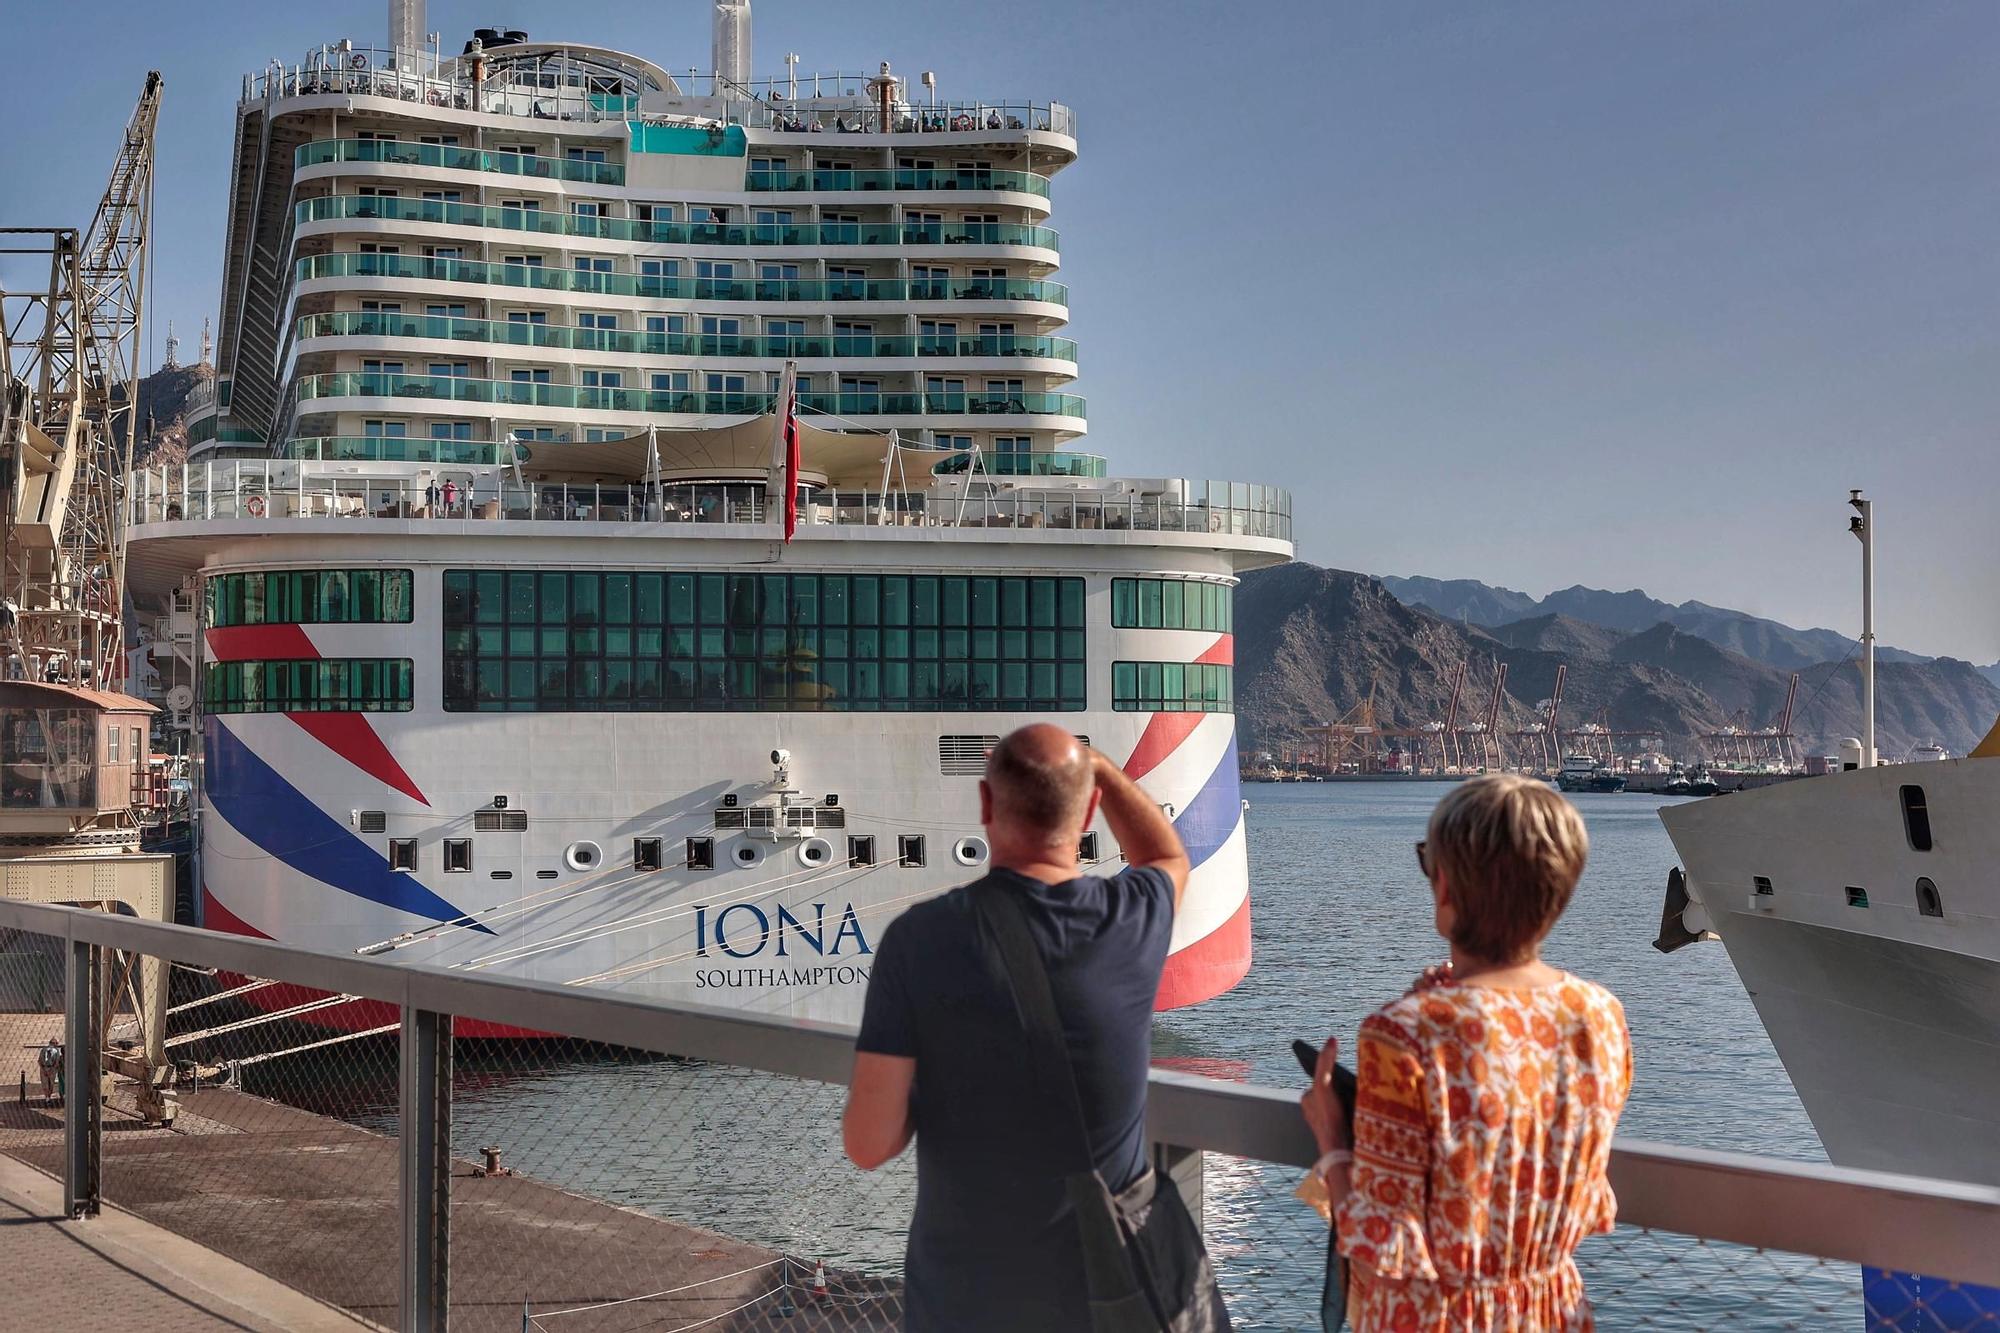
[0,905,2000,1333]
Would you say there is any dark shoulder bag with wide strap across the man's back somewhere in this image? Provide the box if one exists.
[972,885,1230,1333]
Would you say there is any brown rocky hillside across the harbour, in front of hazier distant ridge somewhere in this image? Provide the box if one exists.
[1236,562,2000,757]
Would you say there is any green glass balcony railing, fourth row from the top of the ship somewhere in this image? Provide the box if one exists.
[298,310,1076,364]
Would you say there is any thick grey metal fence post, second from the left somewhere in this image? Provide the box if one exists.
[400,1007,452,1333]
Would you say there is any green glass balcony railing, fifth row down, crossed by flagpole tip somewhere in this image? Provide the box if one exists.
[298,370,1084,416]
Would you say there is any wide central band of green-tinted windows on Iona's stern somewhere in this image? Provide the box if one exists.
[442,568,1086,713]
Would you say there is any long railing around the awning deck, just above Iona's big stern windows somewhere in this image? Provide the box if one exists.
[124,456,1292,540]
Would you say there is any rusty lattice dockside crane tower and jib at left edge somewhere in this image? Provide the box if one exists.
[0,70,160,691]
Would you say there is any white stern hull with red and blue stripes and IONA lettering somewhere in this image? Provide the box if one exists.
[200,624,1250,1027]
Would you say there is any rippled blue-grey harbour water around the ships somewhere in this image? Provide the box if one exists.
[292,783,1832,1329]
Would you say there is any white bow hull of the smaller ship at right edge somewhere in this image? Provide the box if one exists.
[1660,759,2000,1185]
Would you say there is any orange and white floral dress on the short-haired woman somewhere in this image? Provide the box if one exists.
[1336,975,1632,1333]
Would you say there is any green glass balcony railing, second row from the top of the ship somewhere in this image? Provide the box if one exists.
[296,194,1060,250]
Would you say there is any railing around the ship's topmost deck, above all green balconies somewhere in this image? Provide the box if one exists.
[242,46,1076,138]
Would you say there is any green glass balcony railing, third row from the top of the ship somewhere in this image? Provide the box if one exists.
[298,252,1070,306]
